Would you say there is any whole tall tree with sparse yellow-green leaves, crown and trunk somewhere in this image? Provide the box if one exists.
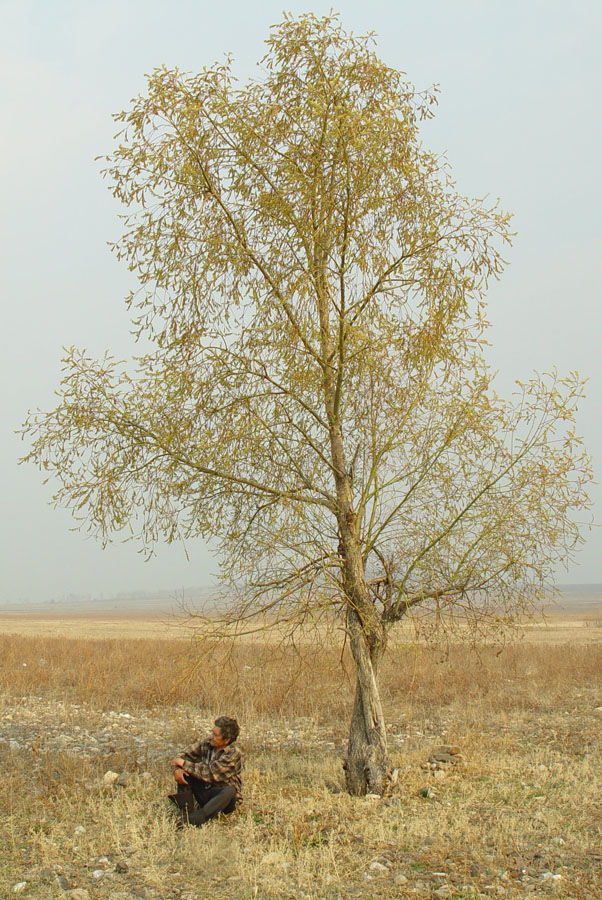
[24,15,590,793]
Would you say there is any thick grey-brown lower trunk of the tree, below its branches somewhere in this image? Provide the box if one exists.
[344,610,391,796]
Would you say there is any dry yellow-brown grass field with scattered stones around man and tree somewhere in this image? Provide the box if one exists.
[0,610,602,900]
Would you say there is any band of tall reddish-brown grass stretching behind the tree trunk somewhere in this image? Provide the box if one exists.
[0,635,602,719]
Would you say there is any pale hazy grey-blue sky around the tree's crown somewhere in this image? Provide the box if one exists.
[0,0,602,601]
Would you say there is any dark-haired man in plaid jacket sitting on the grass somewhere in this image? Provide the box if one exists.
[169,716,242,825]
